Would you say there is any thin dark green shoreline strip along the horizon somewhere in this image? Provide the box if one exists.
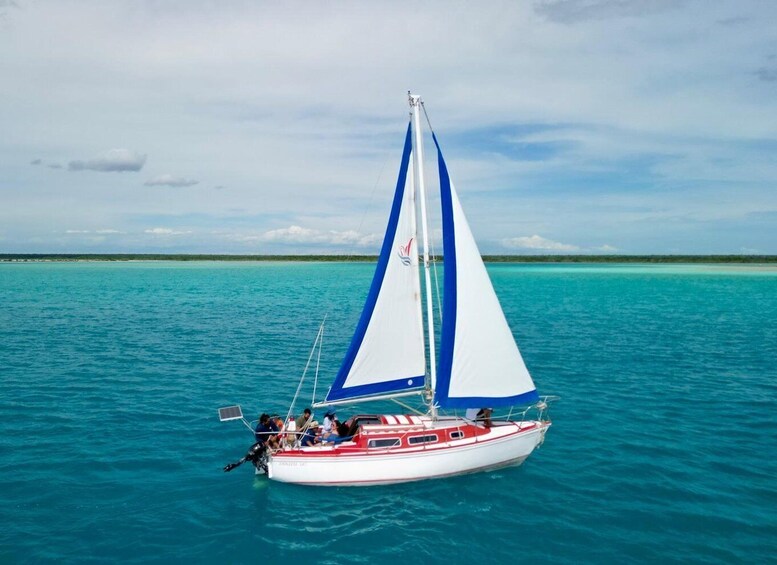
[0,253,777,264]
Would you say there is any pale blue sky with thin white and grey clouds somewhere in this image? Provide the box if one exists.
[0,0,777,254]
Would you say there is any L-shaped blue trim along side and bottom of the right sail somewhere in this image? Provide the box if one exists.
[432,134,540,408]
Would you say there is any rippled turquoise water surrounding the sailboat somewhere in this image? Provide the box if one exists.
[0,263,777,563]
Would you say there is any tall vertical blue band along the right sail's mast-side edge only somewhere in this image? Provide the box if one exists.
[432,133,457,408]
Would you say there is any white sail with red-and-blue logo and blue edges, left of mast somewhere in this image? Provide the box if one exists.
[325,125,426,402]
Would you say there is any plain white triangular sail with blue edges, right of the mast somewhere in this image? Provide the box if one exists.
[433,135,539,408]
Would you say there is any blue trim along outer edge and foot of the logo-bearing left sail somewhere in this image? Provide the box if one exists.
[326,124,416,401]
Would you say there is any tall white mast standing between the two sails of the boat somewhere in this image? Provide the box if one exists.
[407,92,437,418]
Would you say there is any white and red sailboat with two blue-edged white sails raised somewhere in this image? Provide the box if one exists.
[218,93,551,486]
